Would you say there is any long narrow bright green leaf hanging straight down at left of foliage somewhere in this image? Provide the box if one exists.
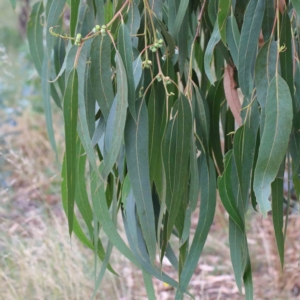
[63,69,78,235]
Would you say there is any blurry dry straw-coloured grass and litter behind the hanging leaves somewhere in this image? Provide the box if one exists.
[0,110,300,300]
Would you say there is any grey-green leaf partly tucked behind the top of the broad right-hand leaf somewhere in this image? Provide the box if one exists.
[255,39,277,107]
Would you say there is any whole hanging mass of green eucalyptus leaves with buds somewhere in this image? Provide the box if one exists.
[11,0,300,299]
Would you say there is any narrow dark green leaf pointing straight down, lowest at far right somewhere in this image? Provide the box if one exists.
[271,178,284,268]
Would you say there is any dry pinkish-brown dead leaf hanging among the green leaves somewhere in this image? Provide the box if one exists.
[223,65,242,126]
